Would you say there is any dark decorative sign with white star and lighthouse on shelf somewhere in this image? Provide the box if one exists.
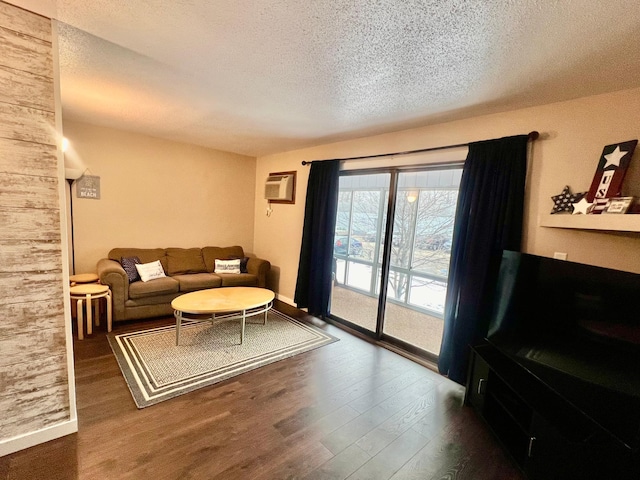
[587,140,638,203]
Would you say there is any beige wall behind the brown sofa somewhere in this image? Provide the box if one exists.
[63,121,256,273]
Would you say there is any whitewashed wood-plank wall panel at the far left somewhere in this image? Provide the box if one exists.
[0,1,77,455]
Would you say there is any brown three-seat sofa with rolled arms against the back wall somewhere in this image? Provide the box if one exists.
[97,246,271,322]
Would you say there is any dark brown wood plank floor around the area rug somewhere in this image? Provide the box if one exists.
[0,303,523,480]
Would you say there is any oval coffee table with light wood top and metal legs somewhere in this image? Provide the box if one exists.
[171,287,275,345]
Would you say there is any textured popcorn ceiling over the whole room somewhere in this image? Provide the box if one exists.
[13,0,640,156]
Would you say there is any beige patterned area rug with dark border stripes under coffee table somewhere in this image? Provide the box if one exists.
[107,310,338,408]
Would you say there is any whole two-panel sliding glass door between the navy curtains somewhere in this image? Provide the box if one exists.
[331,167,462,357]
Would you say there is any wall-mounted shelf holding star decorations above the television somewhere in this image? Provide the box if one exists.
[538,213,640,232]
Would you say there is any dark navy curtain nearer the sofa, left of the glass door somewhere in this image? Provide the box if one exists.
[294,160,340,316]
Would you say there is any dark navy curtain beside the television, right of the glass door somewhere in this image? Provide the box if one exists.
[438,135,528,385]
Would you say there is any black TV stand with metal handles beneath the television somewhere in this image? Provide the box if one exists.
[465,344,640,480]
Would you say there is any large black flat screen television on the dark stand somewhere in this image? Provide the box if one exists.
[487,251,640,451]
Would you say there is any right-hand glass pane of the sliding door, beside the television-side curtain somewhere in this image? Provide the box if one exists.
[383,169,461,355]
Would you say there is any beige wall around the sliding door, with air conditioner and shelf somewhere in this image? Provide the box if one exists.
[254,89,640,301]
